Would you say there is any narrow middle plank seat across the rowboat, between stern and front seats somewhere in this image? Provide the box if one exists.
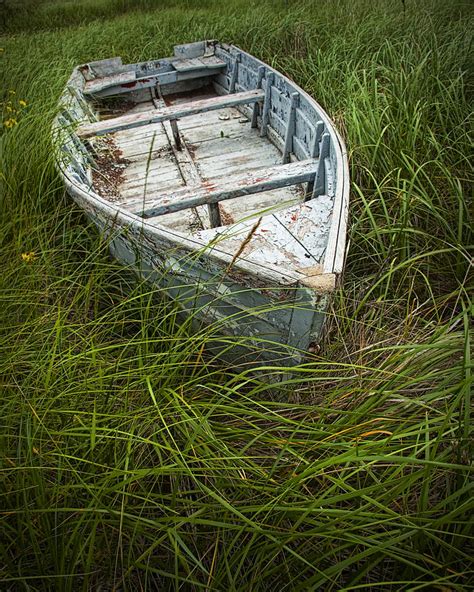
[77,89,265,138]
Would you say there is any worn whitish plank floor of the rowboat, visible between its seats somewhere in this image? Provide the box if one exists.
[93,84,304,233]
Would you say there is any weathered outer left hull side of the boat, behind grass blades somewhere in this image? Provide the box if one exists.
[68,194,314,365]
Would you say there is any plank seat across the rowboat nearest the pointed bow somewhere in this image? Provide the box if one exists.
[126,158,318,218]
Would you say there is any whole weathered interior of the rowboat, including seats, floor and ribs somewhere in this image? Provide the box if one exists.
[66,44,333,267]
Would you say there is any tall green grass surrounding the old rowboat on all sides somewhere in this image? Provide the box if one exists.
[0,0,474,592]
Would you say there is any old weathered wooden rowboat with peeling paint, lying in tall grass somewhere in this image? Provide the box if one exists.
[53,41,349,365]
